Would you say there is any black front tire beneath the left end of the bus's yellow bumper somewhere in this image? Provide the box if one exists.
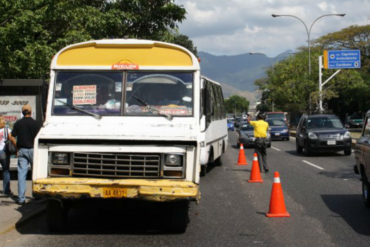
[46,199,68,232]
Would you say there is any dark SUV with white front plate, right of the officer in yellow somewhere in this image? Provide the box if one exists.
[296,114,352,155]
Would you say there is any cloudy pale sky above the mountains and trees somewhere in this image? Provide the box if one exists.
[175,0,370,57]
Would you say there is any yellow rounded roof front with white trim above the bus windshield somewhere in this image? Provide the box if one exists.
[51,39,199,70]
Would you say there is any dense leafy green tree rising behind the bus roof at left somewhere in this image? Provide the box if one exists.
[0,0,186,78]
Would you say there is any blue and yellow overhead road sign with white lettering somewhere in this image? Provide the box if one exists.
[324,50,361,69]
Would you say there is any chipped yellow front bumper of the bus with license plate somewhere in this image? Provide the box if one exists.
[33,178,200,201]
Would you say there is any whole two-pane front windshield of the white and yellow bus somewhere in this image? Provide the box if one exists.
[52,71,193,116]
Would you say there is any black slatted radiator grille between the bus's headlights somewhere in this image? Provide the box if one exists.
[72,153,161,178]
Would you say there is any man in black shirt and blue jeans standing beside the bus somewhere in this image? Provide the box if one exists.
[9,105,41,205]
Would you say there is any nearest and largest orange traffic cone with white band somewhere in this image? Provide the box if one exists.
[266,172,290,217]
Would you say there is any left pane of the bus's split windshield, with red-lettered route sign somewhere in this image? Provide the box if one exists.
[52,72,122,116]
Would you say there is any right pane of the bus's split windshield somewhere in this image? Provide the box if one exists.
[125,72,193,116]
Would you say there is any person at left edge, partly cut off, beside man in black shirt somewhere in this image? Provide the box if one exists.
[0,116,12,196]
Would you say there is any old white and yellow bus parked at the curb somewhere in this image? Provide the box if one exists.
[32,39,228,231]
